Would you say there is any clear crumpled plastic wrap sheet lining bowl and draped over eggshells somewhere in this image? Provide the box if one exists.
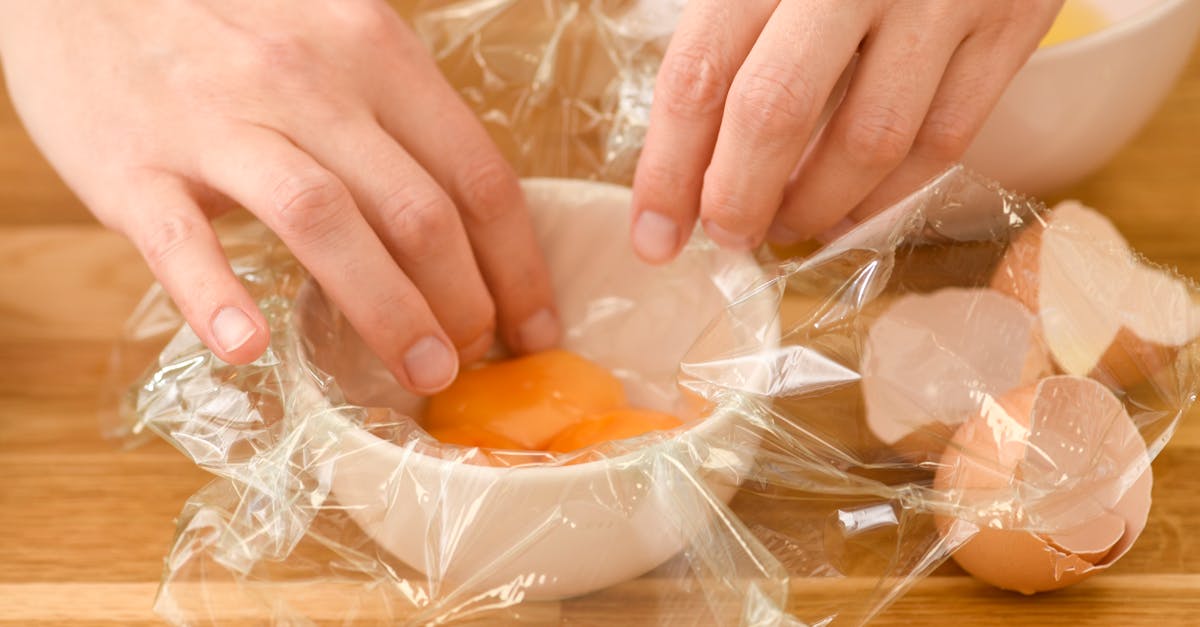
[106,0,1200,625]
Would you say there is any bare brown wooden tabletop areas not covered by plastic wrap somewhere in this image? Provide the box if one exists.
[0,43,1200,627]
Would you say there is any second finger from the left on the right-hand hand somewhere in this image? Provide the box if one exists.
[701,2,872,250]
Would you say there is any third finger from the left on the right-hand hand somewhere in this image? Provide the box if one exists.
[768,13,966,245]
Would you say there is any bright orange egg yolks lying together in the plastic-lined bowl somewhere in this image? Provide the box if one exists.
[425,351,682,453]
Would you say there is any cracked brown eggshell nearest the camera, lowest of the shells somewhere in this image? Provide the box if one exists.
[935,376,1152,595]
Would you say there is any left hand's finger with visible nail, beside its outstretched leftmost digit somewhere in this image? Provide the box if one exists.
[200,126,458,394]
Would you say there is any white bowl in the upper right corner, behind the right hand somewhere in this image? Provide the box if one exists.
[964,0,1200,195]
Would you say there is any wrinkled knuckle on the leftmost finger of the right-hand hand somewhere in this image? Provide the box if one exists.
[658,42,728,115]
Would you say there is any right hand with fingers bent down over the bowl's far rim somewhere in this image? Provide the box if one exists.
[632,0,1062,262]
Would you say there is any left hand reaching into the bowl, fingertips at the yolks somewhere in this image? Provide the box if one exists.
[0,0,560,393]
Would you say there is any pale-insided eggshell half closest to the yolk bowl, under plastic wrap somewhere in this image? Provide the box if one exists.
[860,287,1050,459]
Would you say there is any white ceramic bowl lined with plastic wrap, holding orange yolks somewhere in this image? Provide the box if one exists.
[296,179,779,599]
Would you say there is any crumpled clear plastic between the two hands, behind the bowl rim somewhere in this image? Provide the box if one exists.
[392,0,686,183]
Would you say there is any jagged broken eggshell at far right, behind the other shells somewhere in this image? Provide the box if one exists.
[991,202,1200,387]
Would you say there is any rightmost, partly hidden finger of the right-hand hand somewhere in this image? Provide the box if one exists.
[850,11,1054,221]
